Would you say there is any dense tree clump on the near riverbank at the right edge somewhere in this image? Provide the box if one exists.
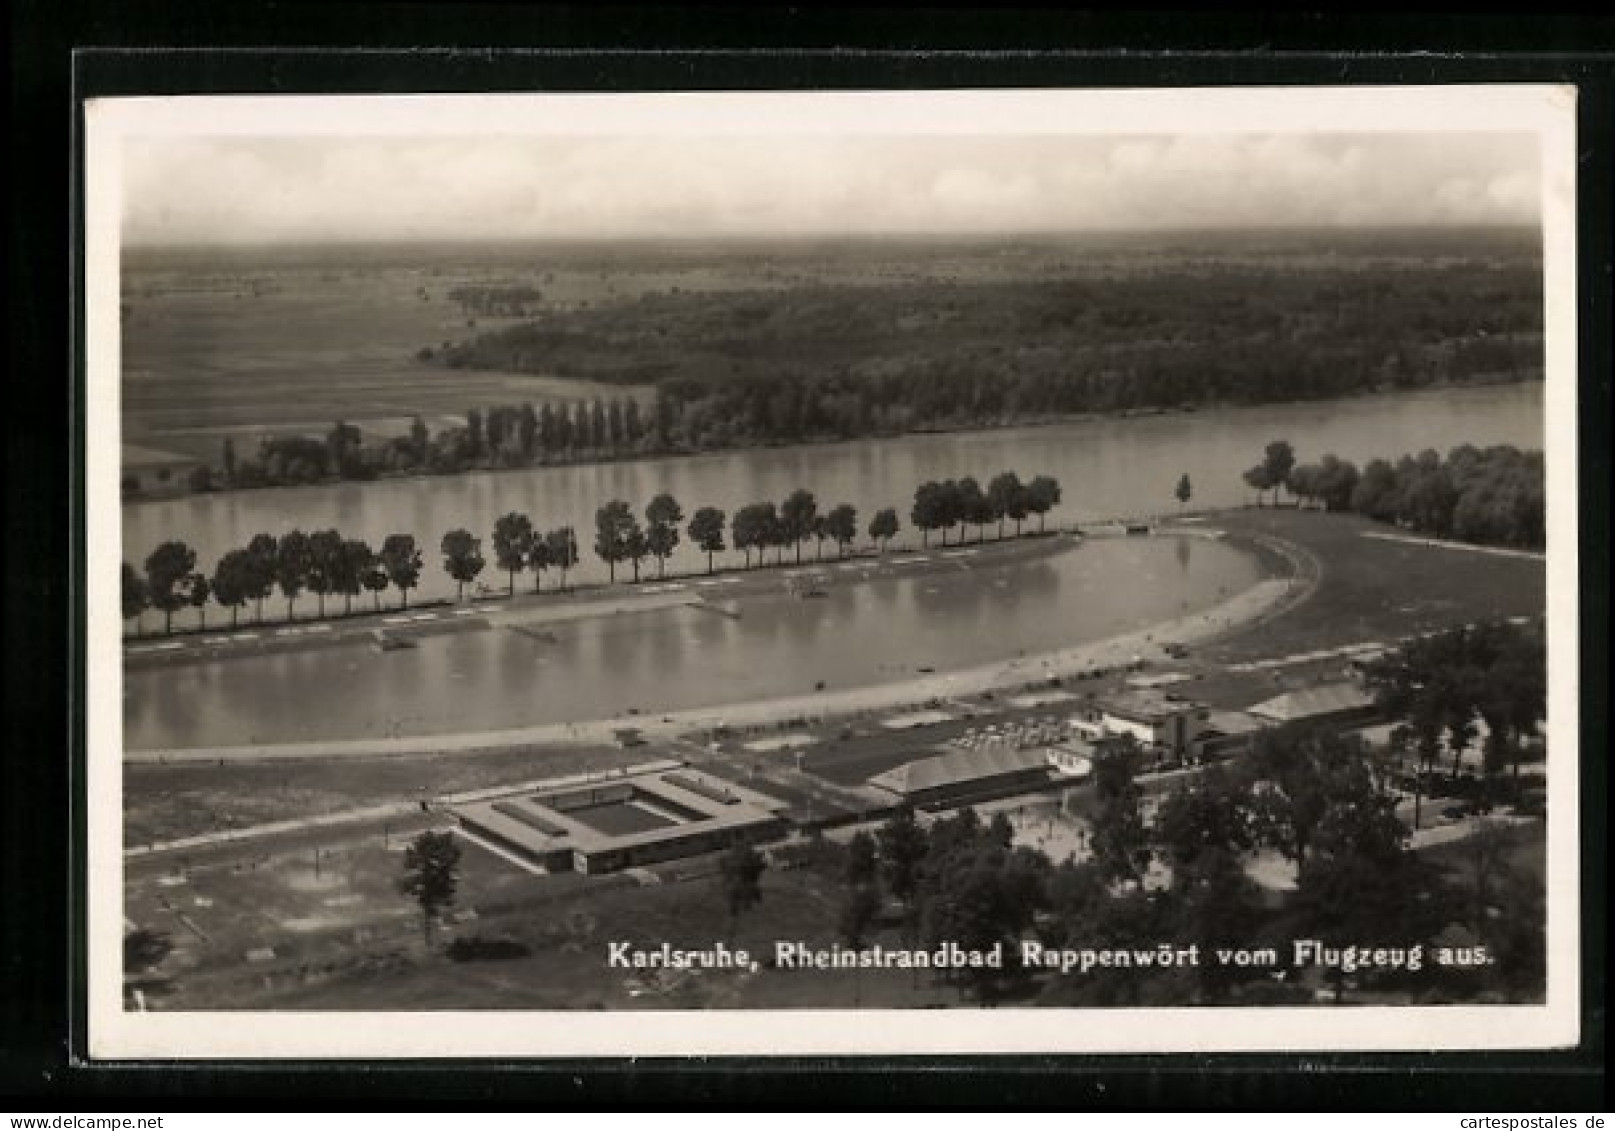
[1244,439,1547,549]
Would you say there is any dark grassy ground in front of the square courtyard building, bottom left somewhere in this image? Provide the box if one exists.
[128,839,961,1010]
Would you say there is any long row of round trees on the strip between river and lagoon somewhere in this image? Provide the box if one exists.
[123,472,1061,633]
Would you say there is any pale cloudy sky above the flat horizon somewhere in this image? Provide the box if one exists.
[123,132,1541,244]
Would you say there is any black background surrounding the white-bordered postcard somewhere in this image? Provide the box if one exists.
[0,0,1615,1115]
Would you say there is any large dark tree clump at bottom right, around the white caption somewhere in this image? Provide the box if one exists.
[813,729,1544,1005]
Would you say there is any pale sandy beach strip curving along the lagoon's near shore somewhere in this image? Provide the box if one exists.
[132,552,1316,764]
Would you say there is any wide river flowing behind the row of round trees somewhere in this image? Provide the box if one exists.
[123,385,1542,610]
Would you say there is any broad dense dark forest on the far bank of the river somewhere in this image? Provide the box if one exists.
[428,257,1542,449]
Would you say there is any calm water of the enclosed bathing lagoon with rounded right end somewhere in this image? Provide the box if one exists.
[124,538,1258,748]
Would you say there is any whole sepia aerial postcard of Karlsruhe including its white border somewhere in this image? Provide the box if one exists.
[84,84,1584,1060]
